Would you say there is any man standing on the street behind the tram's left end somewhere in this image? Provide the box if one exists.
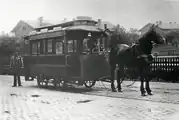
[10,51,24,87]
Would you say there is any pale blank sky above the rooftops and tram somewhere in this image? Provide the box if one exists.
[0,0,179,32]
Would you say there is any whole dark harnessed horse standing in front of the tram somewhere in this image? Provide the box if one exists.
[109,24,165,96]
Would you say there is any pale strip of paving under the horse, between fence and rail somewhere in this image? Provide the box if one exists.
[86,81,179,104]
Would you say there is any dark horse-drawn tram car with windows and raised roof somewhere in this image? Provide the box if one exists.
[24,20,110,88]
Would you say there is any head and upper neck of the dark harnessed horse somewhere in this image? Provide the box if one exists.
[139,25,165,54]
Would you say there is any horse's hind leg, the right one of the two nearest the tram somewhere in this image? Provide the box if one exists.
[117,65,124,92]
